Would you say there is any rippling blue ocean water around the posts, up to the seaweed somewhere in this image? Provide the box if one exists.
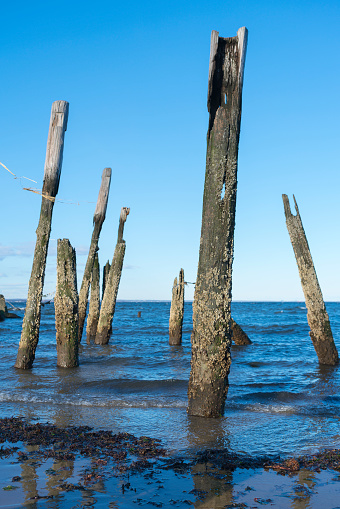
[0,301,340,455]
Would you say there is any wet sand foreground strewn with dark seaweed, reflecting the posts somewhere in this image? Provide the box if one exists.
[0,418,340,509]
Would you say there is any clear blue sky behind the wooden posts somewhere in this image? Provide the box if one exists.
[0,0,340,300]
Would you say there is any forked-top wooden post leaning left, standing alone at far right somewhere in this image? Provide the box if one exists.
[282,194,339,365]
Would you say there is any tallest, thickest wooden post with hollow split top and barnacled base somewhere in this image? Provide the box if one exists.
[188,27,248,417]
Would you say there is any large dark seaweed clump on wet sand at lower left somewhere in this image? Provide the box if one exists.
[0,417,166,472]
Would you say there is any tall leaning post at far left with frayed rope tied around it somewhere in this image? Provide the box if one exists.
[15,101,69,369]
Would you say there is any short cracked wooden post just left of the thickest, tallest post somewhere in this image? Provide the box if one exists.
[169,269,184,346]
